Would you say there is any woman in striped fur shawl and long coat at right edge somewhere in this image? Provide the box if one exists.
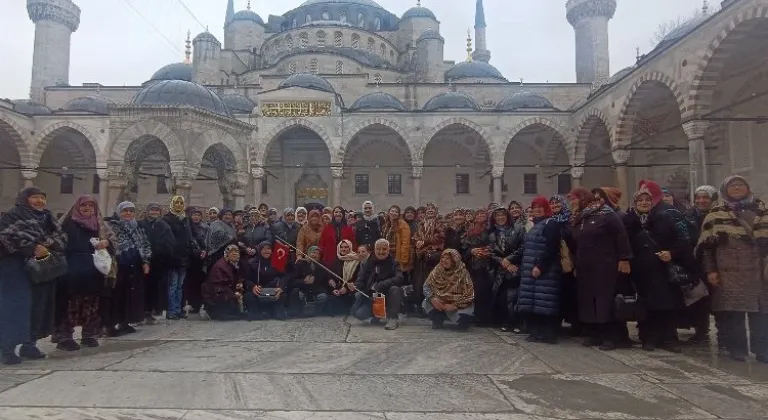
[697,175,768,363]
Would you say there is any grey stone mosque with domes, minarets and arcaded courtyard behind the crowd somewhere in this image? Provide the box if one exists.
[0,0,768,217]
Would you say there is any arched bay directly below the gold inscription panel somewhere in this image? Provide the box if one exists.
[262,125,333,207]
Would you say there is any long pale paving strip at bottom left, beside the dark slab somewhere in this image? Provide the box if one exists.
[0,371,511,412]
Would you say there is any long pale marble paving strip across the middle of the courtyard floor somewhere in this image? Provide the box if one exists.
[108,341,553,375]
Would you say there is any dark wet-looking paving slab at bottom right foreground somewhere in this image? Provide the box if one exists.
[493,374,715,420]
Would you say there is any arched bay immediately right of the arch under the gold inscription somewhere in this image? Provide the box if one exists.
[341,124,414,210]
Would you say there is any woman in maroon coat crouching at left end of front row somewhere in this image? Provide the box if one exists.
[203,245,243,321]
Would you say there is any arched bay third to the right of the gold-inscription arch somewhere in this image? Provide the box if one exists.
[502,123,571,204]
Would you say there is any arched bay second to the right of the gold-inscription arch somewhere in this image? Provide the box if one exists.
[421,123,492,211]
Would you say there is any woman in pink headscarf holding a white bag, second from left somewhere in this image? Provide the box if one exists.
[55,195,117,351]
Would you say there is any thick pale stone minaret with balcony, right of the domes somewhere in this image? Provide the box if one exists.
[565,0,616,86]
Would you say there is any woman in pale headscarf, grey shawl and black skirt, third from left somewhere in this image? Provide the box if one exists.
[104,201,152,337]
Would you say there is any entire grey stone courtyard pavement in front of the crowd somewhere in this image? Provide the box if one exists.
[0,318,768,420]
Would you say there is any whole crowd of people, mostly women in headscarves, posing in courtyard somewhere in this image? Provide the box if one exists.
[0,176,768,364]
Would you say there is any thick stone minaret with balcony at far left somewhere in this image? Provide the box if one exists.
[27,0,80,104]
